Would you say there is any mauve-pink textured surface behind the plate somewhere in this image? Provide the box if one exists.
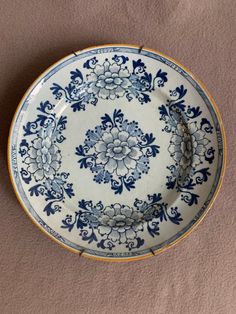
[0,0,236,314]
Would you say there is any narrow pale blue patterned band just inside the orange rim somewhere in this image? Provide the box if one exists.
[10,46,224,258]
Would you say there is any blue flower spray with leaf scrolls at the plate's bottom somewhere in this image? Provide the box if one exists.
[61,193,183,251]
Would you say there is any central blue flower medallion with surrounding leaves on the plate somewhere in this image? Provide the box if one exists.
[75,109,160,194]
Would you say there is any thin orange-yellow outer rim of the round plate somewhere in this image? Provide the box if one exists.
[7,44,227,262]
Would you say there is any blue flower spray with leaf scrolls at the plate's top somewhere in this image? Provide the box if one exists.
[50,55,168,111]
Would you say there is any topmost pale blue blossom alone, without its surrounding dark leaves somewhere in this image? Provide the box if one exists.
[87,60,132,99]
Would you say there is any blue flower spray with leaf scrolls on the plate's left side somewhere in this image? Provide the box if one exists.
[19,101,74,216]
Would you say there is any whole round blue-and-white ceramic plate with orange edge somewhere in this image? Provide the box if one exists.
[9,45,225,261]
